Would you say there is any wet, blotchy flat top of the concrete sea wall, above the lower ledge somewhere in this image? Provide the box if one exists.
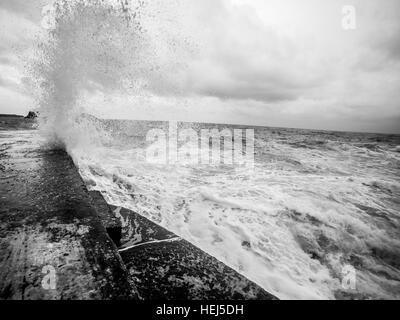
[0,131,137,300]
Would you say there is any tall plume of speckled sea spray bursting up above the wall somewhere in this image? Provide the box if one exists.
[33,0,140,147]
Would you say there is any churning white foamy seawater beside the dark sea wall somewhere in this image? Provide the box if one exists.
[68,124,400,299]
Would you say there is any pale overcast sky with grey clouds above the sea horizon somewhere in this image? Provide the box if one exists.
[0,0,400,133]
